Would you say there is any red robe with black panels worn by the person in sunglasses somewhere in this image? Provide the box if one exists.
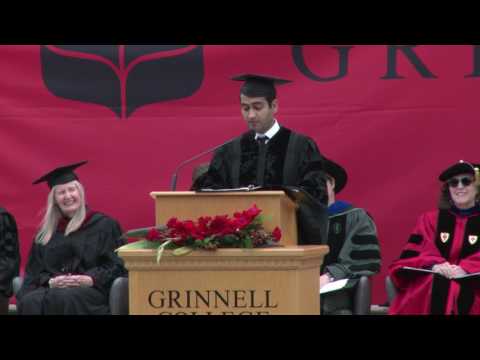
[389,210,480,315]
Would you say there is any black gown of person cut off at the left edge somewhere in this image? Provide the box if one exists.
[0,208,20,298]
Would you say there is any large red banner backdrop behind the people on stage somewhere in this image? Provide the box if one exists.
[0,45,480,303]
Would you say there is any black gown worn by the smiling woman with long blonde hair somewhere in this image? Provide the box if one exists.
[17,213,126,315]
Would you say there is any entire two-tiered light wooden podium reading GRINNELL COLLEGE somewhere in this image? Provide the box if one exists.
[119,191,328,315]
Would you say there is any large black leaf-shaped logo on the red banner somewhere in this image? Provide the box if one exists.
[41,45,204,118]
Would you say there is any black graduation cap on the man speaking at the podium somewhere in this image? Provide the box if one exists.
[232,74,291,99]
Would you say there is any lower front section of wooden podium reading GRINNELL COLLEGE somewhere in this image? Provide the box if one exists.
[119,246,328,315]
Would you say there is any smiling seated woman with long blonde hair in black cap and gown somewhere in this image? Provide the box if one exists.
[17,161,126,315]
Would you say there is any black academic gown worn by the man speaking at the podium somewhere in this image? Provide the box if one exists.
[192,127,328,244]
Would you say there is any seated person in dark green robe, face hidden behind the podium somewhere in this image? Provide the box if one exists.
[320,159,381,315]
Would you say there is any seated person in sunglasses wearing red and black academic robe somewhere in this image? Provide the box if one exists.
[389,161,480,315]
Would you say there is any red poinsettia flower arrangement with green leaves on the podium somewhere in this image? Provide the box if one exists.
[117,204,282,262]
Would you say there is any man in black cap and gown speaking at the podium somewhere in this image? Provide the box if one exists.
[192,74,328,244]
